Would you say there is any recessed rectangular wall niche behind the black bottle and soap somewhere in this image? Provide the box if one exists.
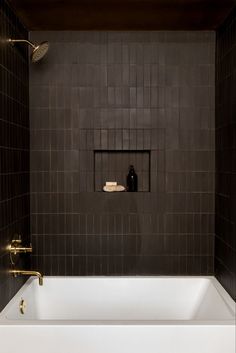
[94,150,150,192]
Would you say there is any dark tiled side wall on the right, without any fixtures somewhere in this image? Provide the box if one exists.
[215,9,236,299]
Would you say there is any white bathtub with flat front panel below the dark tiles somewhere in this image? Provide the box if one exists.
[0,277,235,353]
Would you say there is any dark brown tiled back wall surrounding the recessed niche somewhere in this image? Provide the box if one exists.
[30,32,215,275]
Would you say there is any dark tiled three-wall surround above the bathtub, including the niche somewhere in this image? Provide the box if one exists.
[0,1,236,309]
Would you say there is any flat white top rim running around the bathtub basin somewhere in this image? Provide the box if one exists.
[0,276,236,327]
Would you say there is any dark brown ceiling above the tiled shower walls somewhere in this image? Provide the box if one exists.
[10,0,236,30]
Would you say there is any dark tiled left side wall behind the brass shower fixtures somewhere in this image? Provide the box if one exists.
[0,1,30,310]
